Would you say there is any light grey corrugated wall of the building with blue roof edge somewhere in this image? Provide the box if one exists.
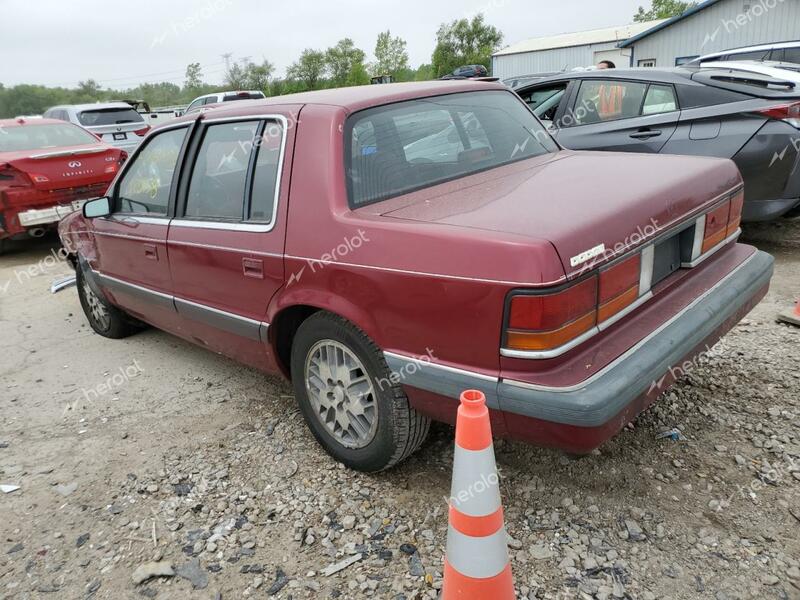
[620,0,800,67]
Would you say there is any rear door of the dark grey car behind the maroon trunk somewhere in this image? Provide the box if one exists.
[558,79,680,153]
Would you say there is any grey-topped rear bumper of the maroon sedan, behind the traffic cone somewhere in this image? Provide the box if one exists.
[386,251,774,452]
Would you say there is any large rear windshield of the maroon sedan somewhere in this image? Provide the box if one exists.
[345,90,558,206]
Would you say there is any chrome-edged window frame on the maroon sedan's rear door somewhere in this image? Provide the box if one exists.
[171,113,289,233]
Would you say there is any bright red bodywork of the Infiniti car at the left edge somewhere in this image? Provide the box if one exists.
[0,119,125,240]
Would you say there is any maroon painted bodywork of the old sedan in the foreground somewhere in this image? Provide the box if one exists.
[60,82,768,452]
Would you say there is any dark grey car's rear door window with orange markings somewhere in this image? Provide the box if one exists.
[574,80,647,125]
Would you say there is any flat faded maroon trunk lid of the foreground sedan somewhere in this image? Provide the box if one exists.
[378,151,741,277]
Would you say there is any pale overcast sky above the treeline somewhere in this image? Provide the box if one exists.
[0,0,649,88]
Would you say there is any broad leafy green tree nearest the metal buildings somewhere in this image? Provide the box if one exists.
[431,14,503,77]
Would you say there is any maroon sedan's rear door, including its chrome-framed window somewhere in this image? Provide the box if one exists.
[167,108,297,369]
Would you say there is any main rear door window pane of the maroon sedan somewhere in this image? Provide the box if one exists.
[185,121,259,221]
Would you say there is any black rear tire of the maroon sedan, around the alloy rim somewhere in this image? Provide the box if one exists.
[291,311,430,472]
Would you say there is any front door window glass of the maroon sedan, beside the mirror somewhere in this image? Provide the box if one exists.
[117,127,187,216]
